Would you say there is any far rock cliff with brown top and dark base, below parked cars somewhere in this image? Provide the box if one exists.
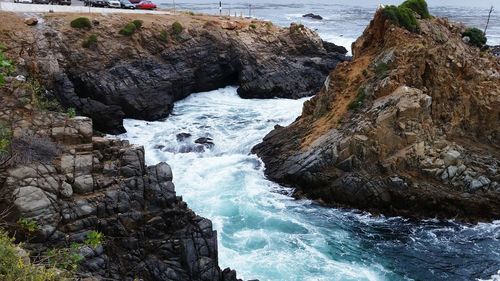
[4,15,347,133]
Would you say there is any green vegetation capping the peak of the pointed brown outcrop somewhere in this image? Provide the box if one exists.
[383,0,431,32]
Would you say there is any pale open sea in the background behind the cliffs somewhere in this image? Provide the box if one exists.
[156,0,500,50]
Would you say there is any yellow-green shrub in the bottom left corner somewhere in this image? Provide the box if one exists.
[0,230,61,281]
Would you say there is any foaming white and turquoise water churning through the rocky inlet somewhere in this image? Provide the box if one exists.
[120,87,500,281]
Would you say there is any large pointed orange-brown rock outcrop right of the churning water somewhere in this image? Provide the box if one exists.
[253,11,500,220]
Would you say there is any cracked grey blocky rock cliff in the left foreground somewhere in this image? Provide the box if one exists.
[0,82,241,281]
